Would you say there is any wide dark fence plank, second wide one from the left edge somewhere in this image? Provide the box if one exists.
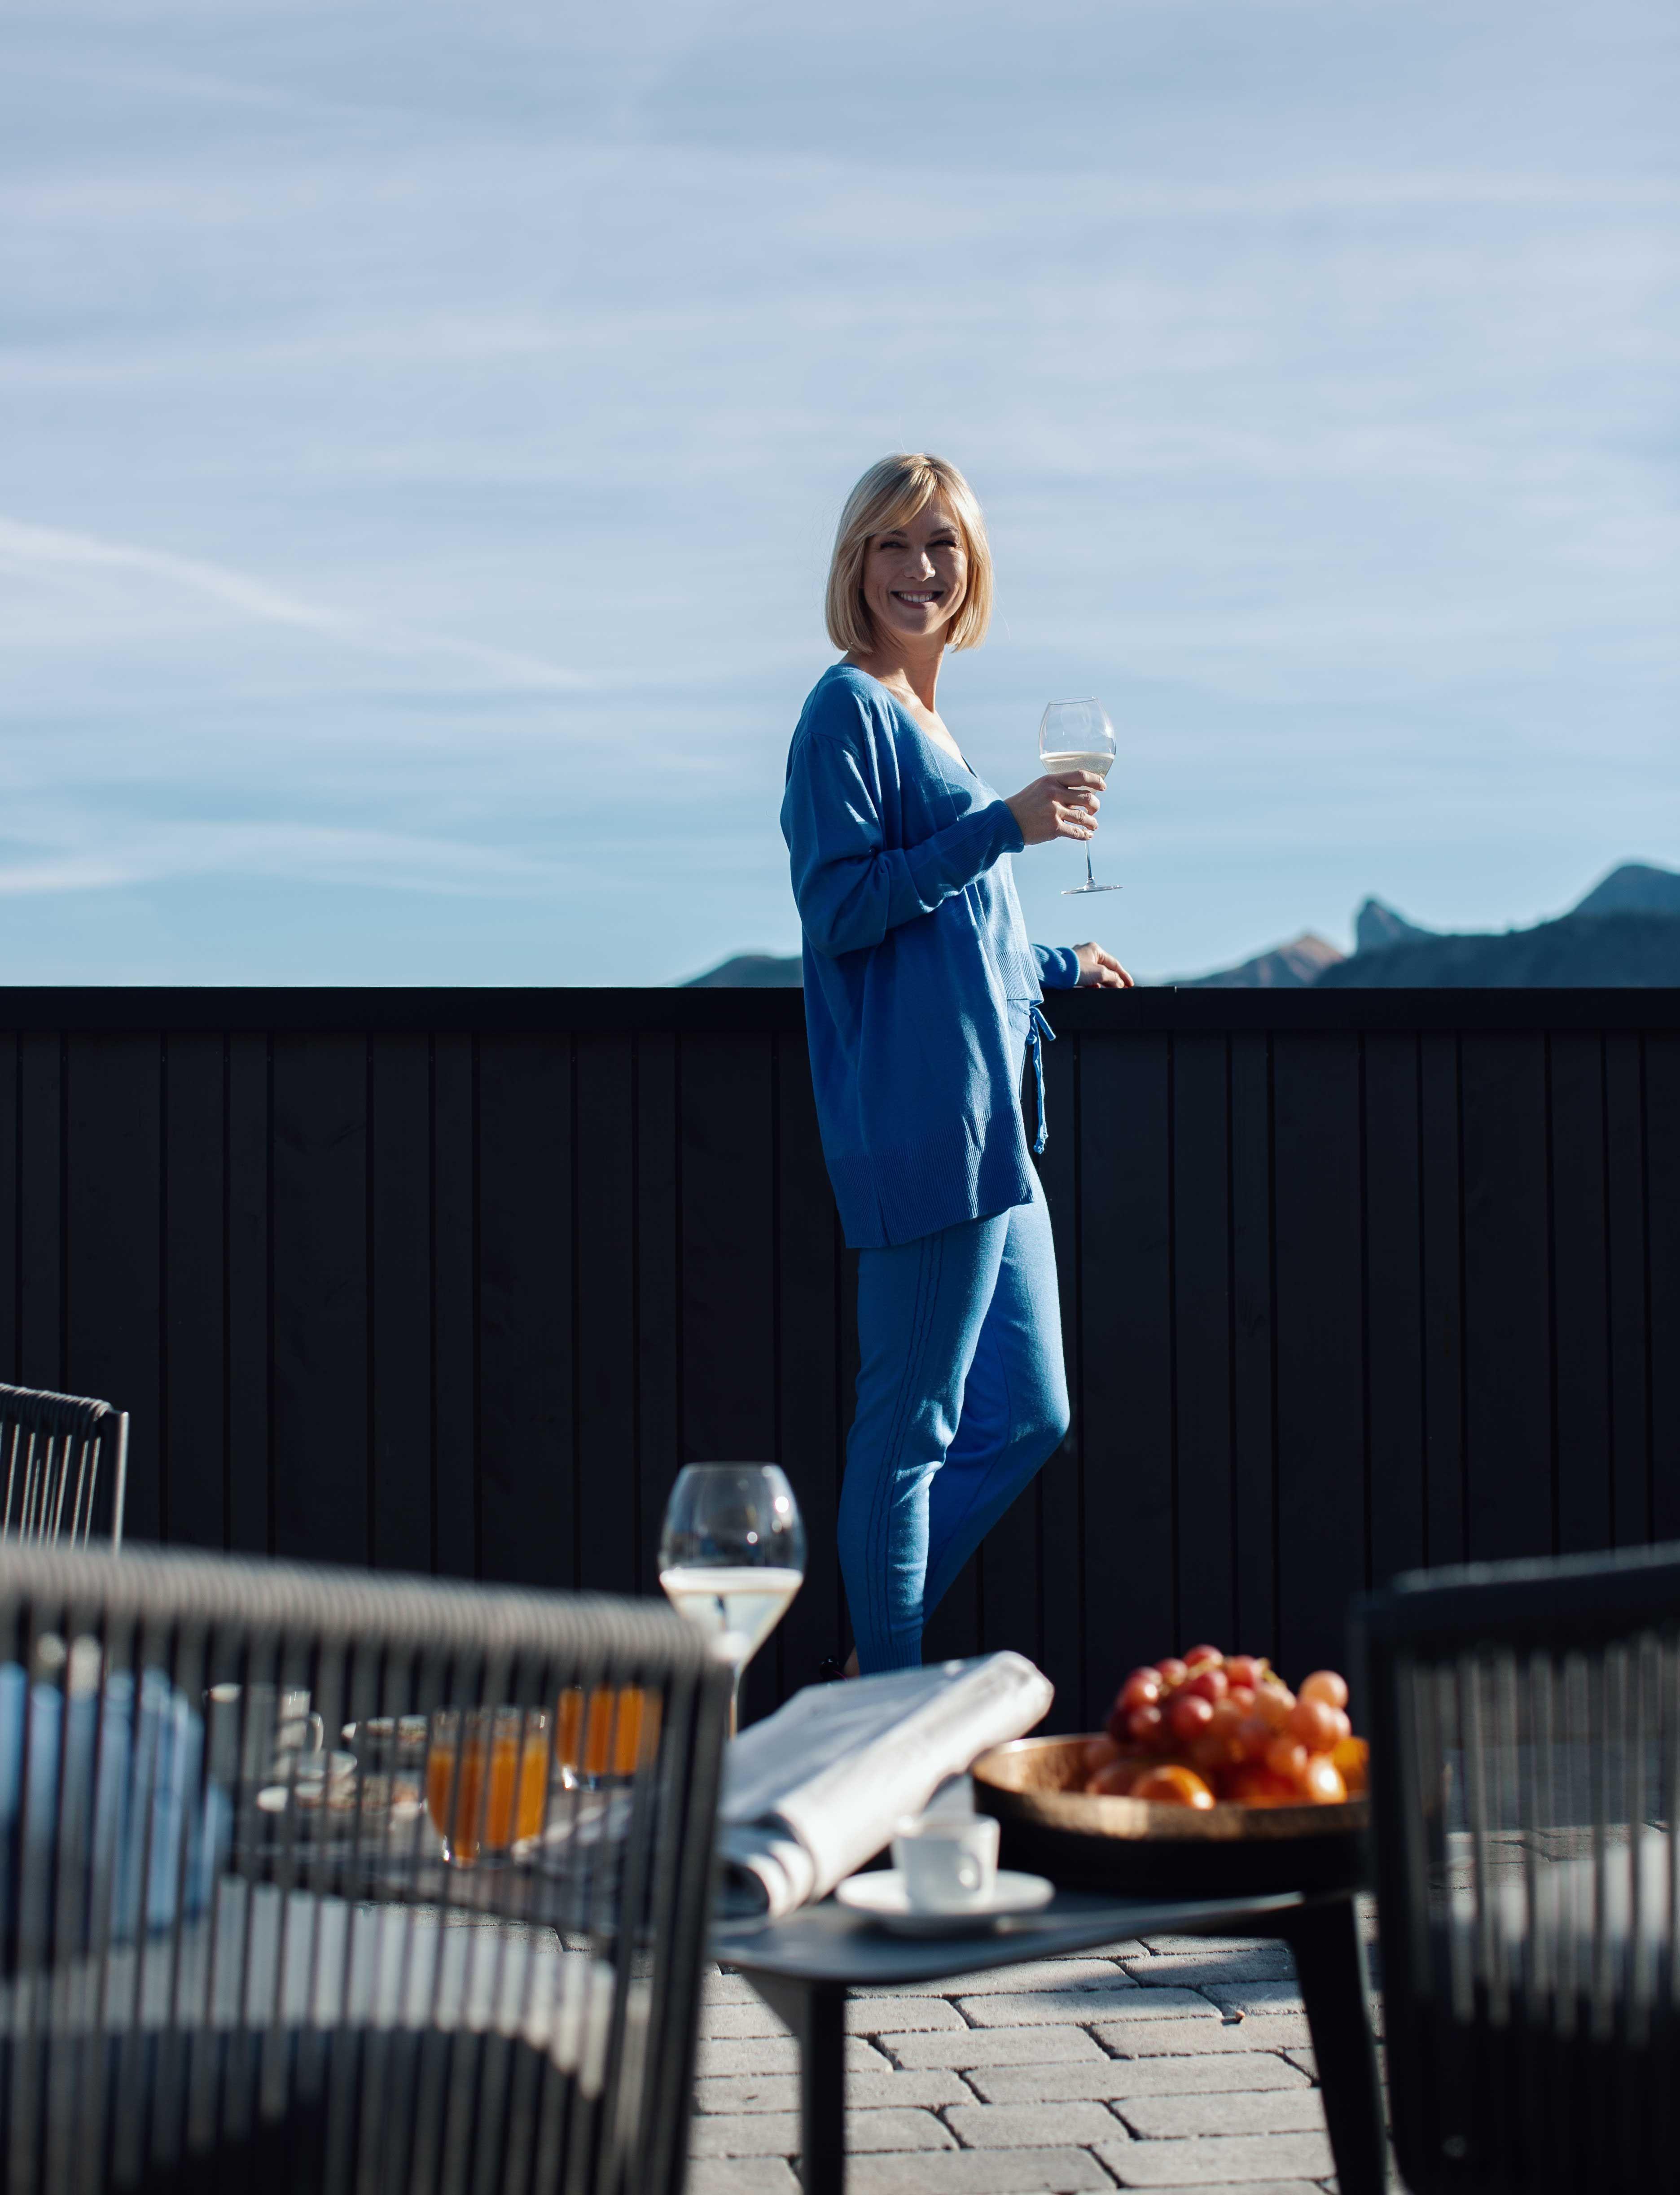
[272,1036,371,1565]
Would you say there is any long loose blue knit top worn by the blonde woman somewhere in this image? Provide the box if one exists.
[782,663,1078,1249]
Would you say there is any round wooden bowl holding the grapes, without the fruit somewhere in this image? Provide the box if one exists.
[973,1739,1370,1897]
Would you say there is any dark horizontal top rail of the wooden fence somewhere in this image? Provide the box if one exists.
[0,986,1680,1036]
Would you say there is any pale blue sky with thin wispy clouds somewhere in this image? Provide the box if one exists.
[0,0,1680,983]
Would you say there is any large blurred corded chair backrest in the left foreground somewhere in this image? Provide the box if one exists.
[0,1541,729,2195]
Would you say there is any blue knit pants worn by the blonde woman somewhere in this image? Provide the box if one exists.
[839,1181,1067,1677]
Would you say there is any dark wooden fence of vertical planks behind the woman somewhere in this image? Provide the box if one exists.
[0,990,1680,1725]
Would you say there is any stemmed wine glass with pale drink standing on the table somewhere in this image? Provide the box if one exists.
[659,1464,806,1739]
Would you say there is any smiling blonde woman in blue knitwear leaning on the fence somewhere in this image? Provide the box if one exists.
[782,456,1131,1675]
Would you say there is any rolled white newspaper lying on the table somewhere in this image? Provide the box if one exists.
[718,1653,1056,1921]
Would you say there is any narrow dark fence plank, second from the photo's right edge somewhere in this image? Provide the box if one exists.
[1603,1034,1642,1547]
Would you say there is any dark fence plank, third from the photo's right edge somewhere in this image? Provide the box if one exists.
[1548,1034,1614,1554]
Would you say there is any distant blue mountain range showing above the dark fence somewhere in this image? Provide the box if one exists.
[687,860,1680,990]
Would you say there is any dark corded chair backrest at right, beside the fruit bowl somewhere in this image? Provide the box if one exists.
[1355,1545,1680,2195]
